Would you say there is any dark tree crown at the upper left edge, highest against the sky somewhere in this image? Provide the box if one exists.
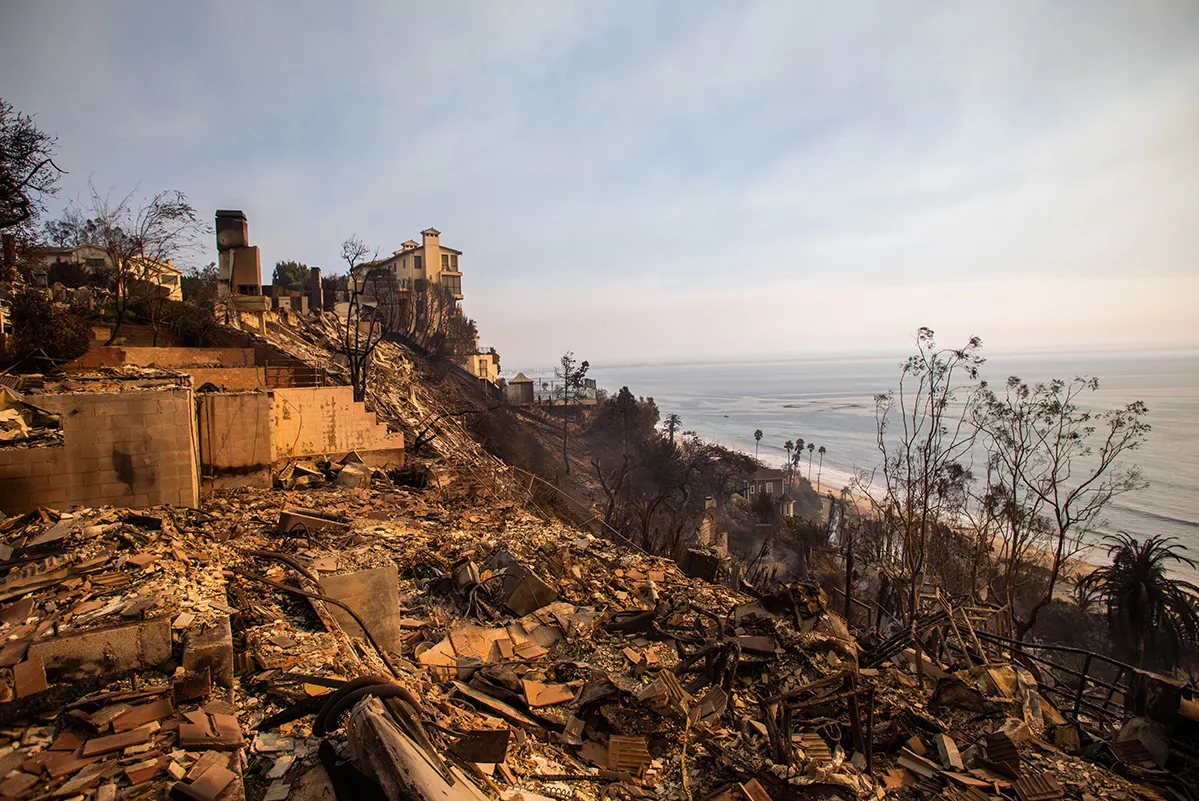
[0,98,64,234]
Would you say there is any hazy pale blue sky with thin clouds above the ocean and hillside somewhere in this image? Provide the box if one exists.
[0,0,1199,369]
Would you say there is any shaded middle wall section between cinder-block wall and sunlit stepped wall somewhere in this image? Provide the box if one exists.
[197,392,271,488]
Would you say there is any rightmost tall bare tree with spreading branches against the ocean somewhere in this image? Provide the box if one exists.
[977,377,1150,638]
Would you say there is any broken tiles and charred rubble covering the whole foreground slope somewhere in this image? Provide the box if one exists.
[0,321,1199,801]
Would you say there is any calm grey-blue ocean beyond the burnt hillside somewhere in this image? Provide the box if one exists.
[515,350,1199,583]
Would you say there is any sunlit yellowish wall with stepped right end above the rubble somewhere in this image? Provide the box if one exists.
[271,386,404,462]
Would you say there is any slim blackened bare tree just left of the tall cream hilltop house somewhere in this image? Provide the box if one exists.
[342,236,398,403]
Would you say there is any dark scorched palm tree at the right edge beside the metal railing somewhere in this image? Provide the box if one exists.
[1081,531,1199,667]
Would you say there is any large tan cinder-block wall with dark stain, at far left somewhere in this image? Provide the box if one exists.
[0,389,199,514]
